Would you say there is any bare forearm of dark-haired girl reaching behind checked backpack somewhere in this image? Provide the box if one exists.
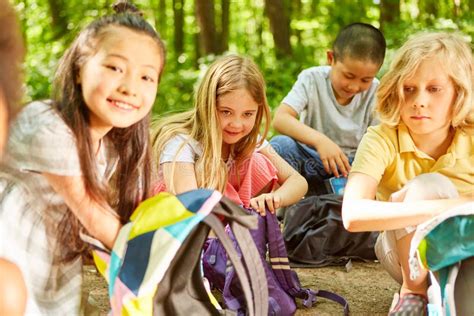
[43,173,122,249]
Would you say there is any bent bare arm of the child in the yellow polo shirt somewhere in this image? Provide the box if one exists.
[342,172,469,232]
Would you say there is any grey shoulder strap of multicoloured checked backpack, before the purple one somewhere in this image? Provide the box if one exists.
[204,198,268,315]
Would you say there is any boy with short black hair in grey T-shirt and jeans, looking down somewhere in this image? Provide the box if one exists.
[270,23,386,195]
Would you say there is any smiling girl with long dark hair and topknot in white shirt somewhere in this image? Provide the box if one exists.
[0,2,165,315]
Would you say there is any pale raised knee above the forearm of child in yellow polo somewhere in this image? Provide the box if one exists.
[391,173,459,202]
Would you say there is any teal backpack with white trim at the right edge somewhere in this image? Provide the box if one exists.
[409,202,474,316]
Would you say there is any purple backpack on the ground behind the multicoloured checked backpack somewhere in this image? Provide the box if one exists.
[203,210,349,316]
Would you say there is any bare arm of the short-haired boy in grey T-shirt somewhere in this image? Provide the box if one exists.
[273,103,351,177]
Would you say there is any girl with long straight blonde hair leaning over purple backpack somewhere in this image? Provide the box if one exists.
[152,55,307,214]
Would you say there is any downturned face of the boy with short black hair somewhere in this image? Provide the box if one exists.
[327,51,380,105]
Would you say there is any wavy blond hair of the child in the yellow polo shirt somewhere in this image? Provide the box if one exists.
[376,33,474,130]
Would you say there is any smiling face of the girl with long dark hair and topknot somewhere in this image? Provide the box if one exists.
[78,26,163,136]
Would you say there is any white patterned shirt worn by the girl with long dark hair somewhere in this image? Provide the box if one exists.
[0,102,117,315]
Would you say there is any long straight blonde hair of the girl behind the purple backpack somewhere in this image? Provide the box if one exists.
[152,55,270,191]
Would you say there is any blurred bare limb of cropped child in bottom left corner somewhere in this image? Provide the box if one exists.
[0,259,27,315]
